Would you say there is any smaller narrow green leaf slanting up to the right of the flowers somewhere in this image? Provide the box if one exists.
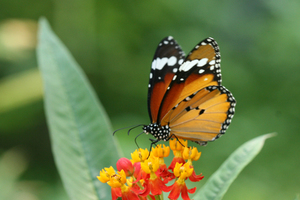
[193,133,274,200]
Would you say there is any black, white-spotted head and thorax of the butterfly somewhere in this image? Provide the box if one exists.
[143,123,171,141]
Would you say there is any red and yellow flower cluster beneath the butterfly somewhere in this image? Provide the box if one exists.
[97,139,204,200]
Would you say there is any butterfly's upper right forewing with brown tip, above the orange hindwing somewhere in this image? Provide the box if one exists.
[158,37,221,122]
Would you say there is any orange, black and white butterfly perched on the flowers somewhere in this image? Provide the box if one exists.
[143,36,236,145]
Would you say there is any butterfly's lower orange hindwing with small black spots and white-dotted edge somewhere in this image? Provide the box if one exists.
[167,86,236,145]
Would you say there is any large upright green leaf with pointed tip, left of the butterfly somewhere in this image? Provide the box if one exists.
[37,18,120,200]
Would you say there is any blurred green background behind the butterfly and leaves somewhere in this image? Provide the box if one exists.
[0,0,300,200]
